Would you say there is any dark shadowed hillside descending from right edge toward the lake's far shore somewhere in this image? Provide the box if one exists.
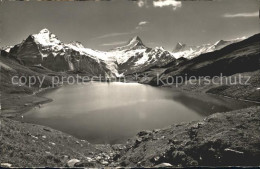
[146,34,260,85]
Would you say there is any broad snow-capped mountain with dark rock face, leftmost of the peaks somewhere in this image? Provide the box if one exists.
[8,28,111,75]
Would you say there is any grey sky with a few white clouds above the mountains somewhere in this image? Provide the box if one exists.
[0,0,260,51]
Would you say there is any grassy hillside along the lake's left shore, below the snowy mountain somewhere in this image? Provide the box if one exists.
[0,57,53,117]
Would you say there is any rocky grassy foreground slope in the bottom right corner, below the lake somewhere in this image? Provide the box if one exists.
[118,107,260,167]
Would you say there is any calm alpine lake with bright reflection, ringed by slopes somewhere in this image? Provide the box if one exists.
[23,82,252,144]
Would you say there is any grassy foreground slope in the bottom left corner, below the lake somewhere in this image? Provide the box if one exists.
[0,118,117,167]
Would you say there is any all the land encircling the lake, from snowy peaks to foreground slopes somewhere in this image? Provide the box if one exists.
[0,29,260,167]
